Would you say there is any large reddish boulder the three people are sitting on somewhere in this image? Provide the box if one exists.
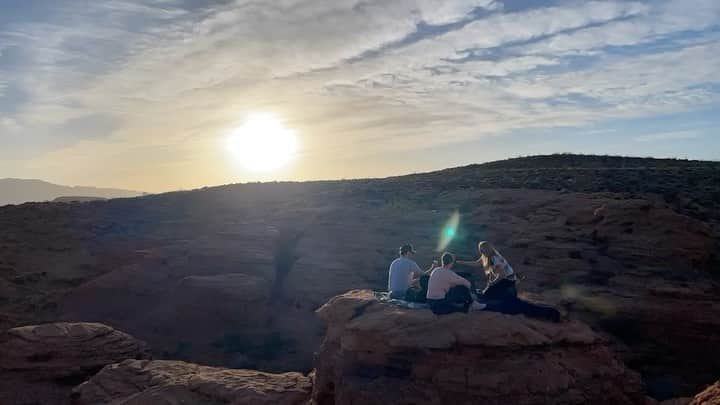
[313,290,646,405]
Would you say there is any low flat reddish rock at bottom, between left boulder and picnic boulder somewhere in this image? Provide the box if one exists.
[72,360,311,405]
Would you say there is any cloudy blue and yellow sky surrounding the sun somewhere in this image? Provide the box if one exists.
[0,0,720,192]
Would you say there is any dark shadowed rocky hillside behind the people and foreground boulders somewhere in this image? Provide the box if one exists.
[0,155,720,399]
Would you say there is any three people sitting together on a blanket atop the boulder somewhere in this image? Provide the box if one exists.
[388,241,560,322]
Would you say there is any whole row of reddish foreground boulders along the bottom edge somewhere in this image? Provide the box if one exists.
[0,290,720,405]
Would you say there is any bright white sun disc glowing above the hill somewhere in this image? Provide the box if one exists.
[227,114,298,171]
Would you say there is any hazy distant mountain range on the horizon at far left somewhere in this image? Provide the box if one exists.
[0,179,145,206]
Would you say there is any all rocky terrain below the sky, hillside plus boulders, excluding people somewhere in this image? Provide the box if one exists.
[0,155,720,405]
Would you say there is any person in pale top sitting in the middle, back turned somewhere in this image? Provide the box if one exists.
[427,253,484,315]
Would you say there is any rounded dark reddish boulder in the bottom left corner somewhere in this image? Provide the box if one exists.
[0,323,148,405]
